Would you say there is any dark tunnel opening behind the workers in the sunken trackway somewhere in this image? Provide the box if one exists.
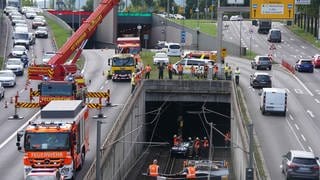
[145,101,231,147]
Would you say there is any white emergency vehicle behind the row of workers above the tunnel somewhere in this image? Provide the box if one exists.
[172,58,214,74]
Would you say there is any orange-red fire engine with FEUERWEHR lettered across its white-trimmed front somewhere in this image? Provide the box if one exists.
[17,100,89,179]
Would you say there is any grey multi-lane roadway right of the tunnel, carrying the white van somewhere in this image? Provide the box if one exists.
[224,22,320,179]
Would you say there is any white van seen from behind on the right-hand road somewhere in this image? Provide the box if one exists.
[259,88,287,116]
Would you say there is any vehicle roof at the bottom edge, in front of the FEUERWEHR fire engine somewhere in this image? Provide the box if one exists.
[26,168,64,180]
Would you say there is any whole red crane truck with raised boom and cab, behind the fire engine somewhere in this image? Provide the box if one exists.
[28,0,119,107]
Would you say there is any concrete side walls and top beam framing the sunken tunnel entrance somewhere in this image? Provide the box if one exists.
[84,80,252,180]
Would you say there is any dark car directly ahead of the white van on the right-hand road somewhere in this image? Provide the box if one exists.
[250,72,272,88]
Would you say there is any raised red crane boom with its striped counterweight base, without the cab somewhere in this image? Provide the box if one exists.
[28,0,119,81]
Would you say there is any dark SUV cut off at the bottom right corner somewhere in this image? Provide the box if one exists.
[281,150,319,180]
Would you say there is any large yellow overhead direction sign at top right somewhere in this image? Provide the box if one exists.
[250,0,294,19]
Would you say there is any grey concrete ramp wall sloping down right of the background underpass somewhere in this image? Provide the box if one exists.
[149,14,240,56]
